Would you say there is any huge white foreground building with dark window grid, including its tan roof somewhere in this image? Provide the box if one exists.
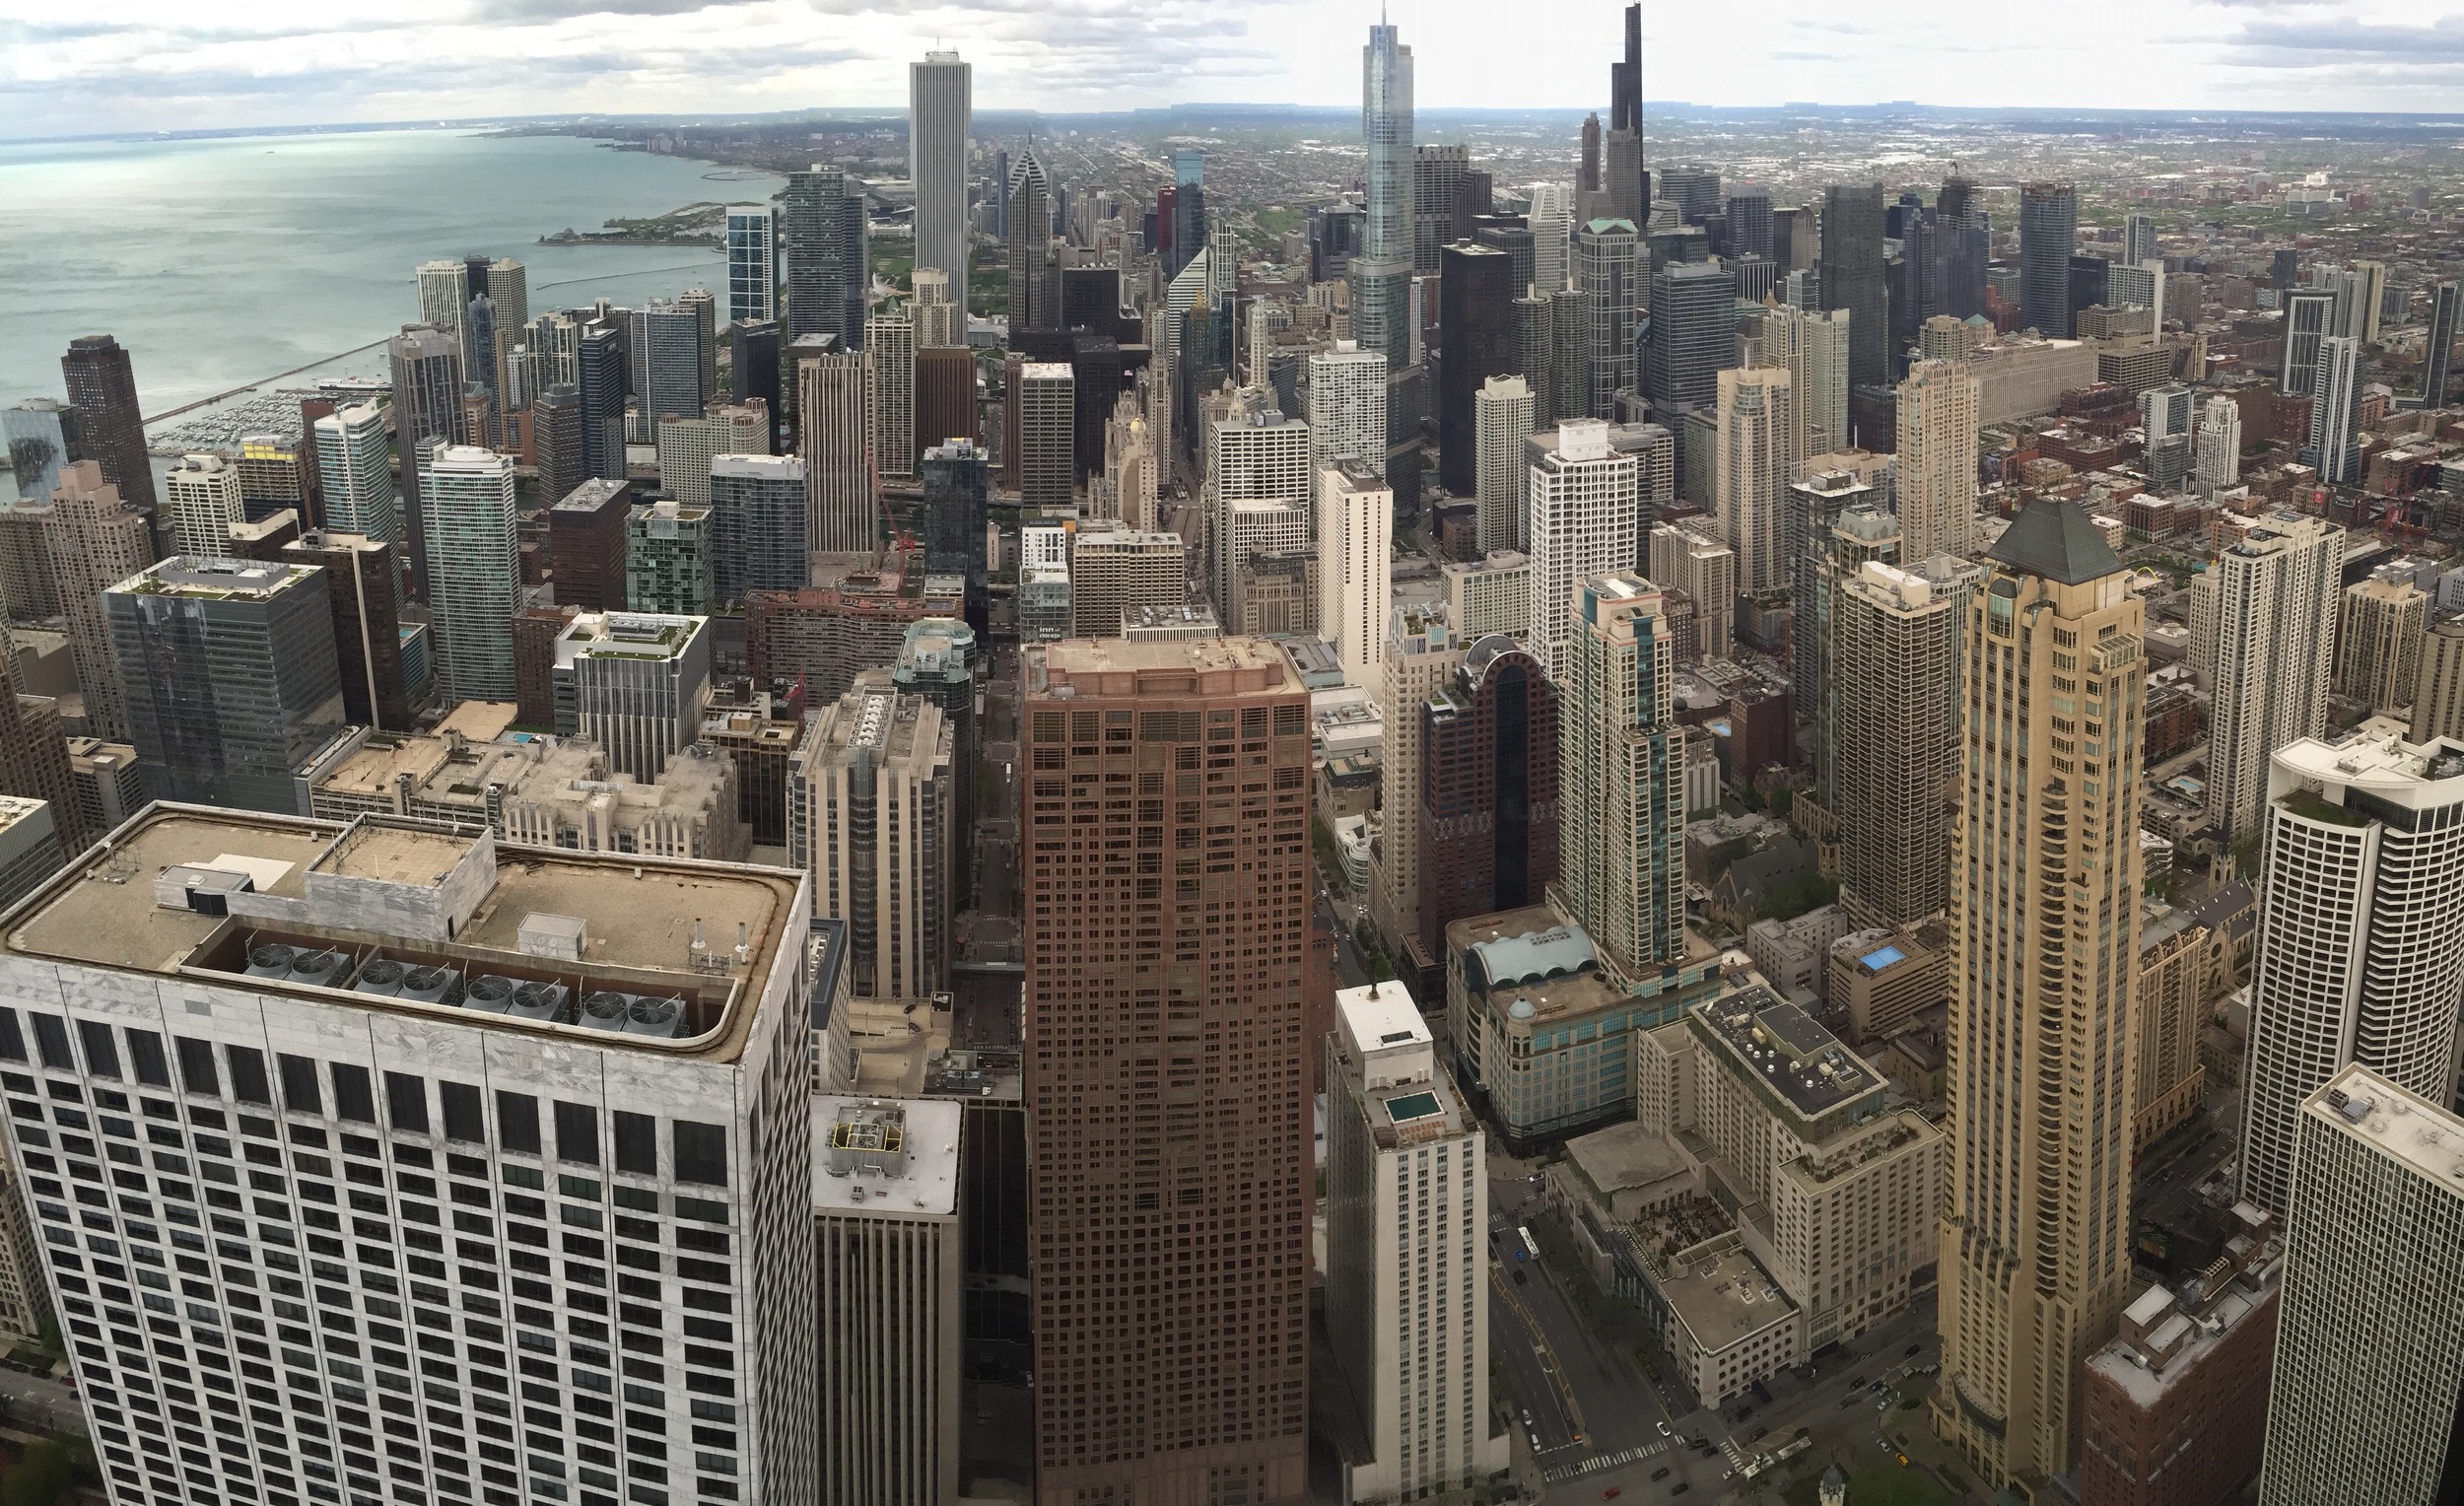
[0,806,821,1501]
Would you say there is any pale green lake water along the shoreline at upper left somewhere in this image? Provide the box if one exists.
[0,131,779,491]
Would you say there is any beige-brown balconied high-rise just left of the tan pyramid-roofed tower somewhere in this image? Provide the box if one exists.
[1823,562,1966,926]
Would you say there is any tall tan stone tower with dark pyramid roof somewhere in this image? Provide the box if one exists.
[1932,501,2147,1491]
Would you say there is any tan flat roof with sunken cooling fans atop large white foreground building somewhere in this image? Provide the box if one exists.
[0,803,801,1060]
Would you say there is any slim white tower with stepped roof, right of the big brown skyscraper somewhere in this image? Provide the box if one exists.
[1326,984,1506,1503]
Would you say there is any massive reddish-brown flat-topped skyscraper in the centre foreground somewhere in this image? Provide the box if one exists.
[1020,639,1311,1506]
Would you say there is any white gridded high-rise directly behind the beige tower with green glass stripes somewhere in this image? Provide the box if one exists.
[1523,419,1641,680]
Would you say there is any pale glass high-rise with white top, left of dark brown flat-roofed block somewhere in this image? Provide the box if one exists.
[419,444,522,705]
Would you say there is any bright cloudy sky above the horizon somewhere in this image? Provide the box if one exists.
[0,0,2464,138]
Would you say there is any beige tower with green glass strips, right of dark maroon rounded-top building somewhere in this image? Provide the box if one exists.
[1557,570,1685,984]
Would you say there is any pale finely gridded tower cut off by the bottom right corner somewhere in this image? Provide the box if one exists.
[2260,1067,2464,1506]
